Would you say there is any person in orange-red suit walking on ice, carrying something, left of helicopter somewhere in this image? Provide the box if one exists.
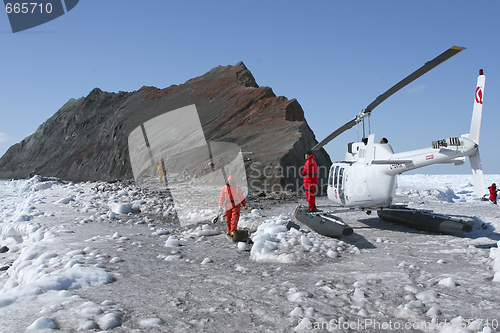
[219,176,246,236]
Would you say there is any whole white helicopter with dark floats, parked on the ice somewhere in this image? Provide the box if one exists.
[296,46,485,236]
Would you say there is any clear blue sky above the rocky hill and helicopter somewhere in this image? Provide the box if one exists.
[0,0,500,174]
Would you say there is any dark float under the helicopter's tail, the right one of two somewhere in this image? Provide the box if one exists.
[377,206,472,233]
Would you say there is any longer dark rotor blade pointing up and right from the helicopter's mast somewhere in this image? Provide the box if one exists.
[364,46,465,113]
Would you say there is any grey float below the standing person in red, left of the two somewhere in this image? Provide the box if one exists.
[295,205,353,237]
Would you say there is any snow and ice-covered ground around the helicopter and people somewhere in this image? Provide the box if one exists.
[0,175,500,333]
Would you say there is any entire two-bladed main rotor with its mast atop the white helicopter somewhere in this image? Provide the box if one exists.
[311,46,465,150]
